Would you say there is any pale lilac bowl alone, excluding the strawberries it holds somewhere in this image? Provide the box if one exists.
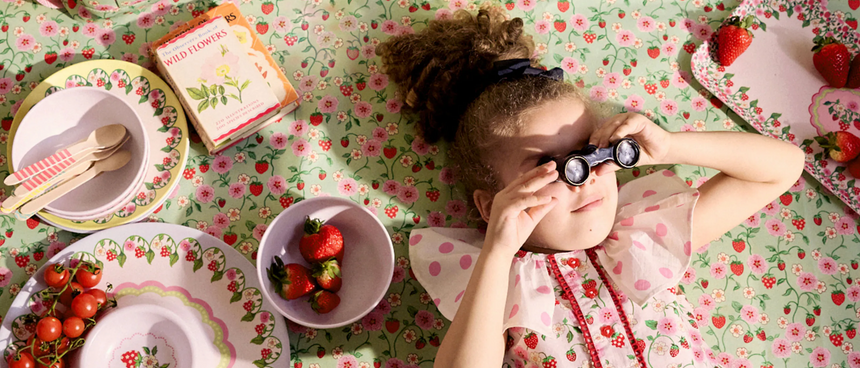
[257,197,394,328]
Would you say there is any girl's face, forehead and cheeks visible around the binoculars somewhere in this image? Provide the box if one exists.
[493,98,618,251]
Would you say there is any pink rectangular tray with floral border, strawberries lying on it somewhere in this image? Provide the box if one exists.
[692,0,860,211]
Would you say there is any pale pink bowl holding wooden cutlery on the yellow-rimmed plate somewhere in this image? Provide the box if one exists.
[11,87,149,217]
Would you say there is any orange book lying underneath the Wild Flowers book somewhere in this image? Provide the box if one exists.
[152,2,301,153]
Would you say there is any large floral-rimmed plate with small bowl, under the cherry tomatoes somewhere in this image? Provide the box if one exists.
[0,223,290,368]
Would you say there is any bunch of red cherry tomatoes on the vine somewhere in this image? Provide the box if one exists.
[6,262,116,368]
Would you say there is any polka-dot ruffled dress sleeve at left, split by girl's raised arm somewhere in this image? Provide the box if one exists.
[409,227,555,334]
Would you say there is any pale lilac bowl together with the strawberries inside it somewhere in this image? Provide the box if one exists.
[252,197,394,329]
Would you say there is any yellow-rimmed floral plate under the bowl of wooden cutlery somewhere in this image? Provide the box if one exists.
[7,60,188,233]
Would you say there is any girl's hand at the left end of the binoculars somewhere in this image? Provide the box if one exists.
[484,161,558,255]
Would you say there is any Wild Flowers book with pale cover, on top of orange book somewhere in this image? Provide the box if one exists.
[154,16,281,153]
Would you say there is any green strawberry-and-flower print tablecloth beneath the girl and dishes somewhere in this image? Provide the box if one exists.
[0,0,860,368]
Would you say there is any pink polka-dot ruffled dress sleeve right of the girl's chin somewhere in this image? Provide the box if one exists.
[597,170,699,305]
